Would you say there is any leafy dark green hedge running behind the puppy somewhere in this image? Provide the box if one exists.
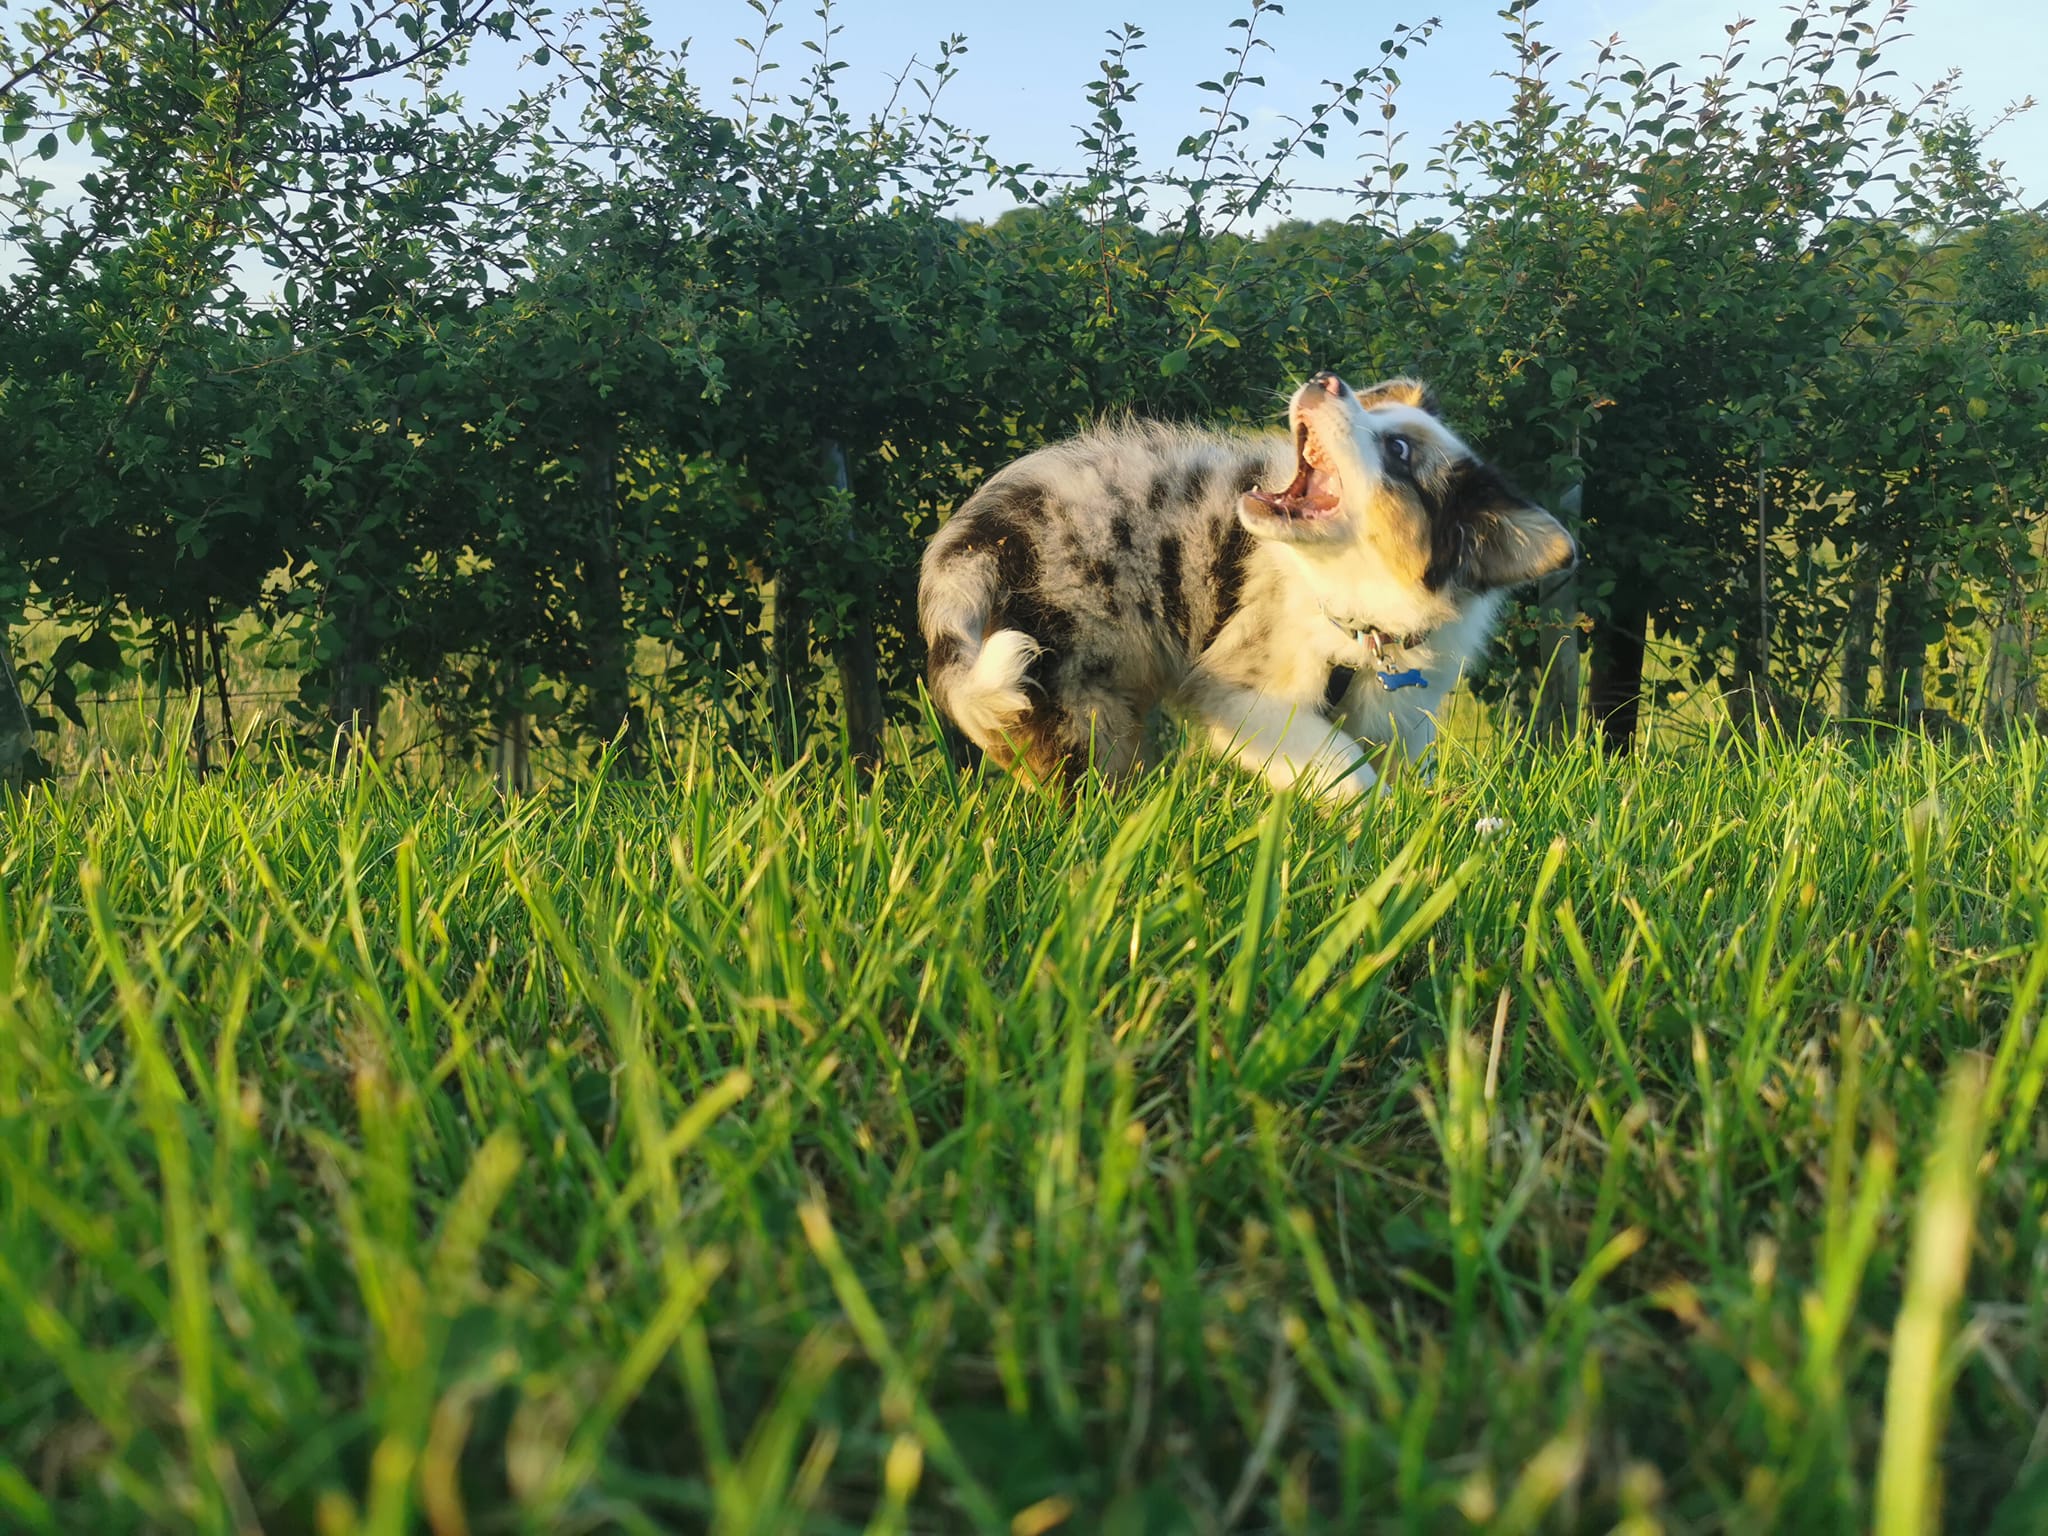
[0,0,2048,794]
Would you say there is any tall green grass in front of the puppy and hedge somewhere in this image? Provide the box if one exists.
[0,737,2048,1536]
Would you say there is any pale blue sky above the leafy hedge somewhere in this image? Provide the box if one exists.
[465,0,2048,213]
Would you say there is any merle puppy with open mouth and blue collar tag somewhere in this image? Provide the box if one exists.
[918,373,1577,799]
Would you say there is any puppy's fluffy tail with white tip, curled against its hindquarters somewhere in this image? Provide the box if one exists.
[918,535,1044,752]
